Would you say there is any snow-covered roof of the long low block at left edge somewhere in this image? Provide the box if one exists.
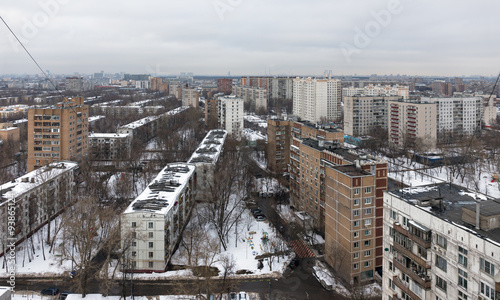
[0,161,78,206]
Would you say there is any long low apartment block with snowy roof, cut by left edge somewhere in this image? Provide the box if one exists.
[0,161,78,256]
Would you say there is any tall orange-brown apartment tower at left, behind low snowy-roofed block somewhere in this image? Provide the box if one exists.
[28,97,89,172]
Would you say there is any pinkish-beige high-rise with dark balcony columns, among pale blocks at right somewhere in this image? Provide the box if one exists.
[388,101,437,149]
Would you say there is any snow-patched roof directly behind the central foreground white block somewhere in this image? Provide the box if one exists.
[188,129,227,164]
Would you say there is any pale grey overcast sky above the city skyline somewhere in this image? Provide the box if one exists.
[0,0,500,76]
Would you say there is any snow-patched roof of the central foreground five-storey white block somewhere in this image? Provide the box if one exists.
[124,163,195,215]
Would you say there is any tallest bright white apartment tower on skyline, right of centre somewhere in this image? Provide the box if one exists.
[293,77,342,123]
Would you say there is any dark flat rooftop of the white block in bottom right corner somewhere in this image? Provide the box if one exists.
[389,182,500,243]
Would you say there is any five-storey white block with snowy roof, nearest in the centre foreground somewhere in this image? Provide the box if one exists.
[120,163,196,273]
